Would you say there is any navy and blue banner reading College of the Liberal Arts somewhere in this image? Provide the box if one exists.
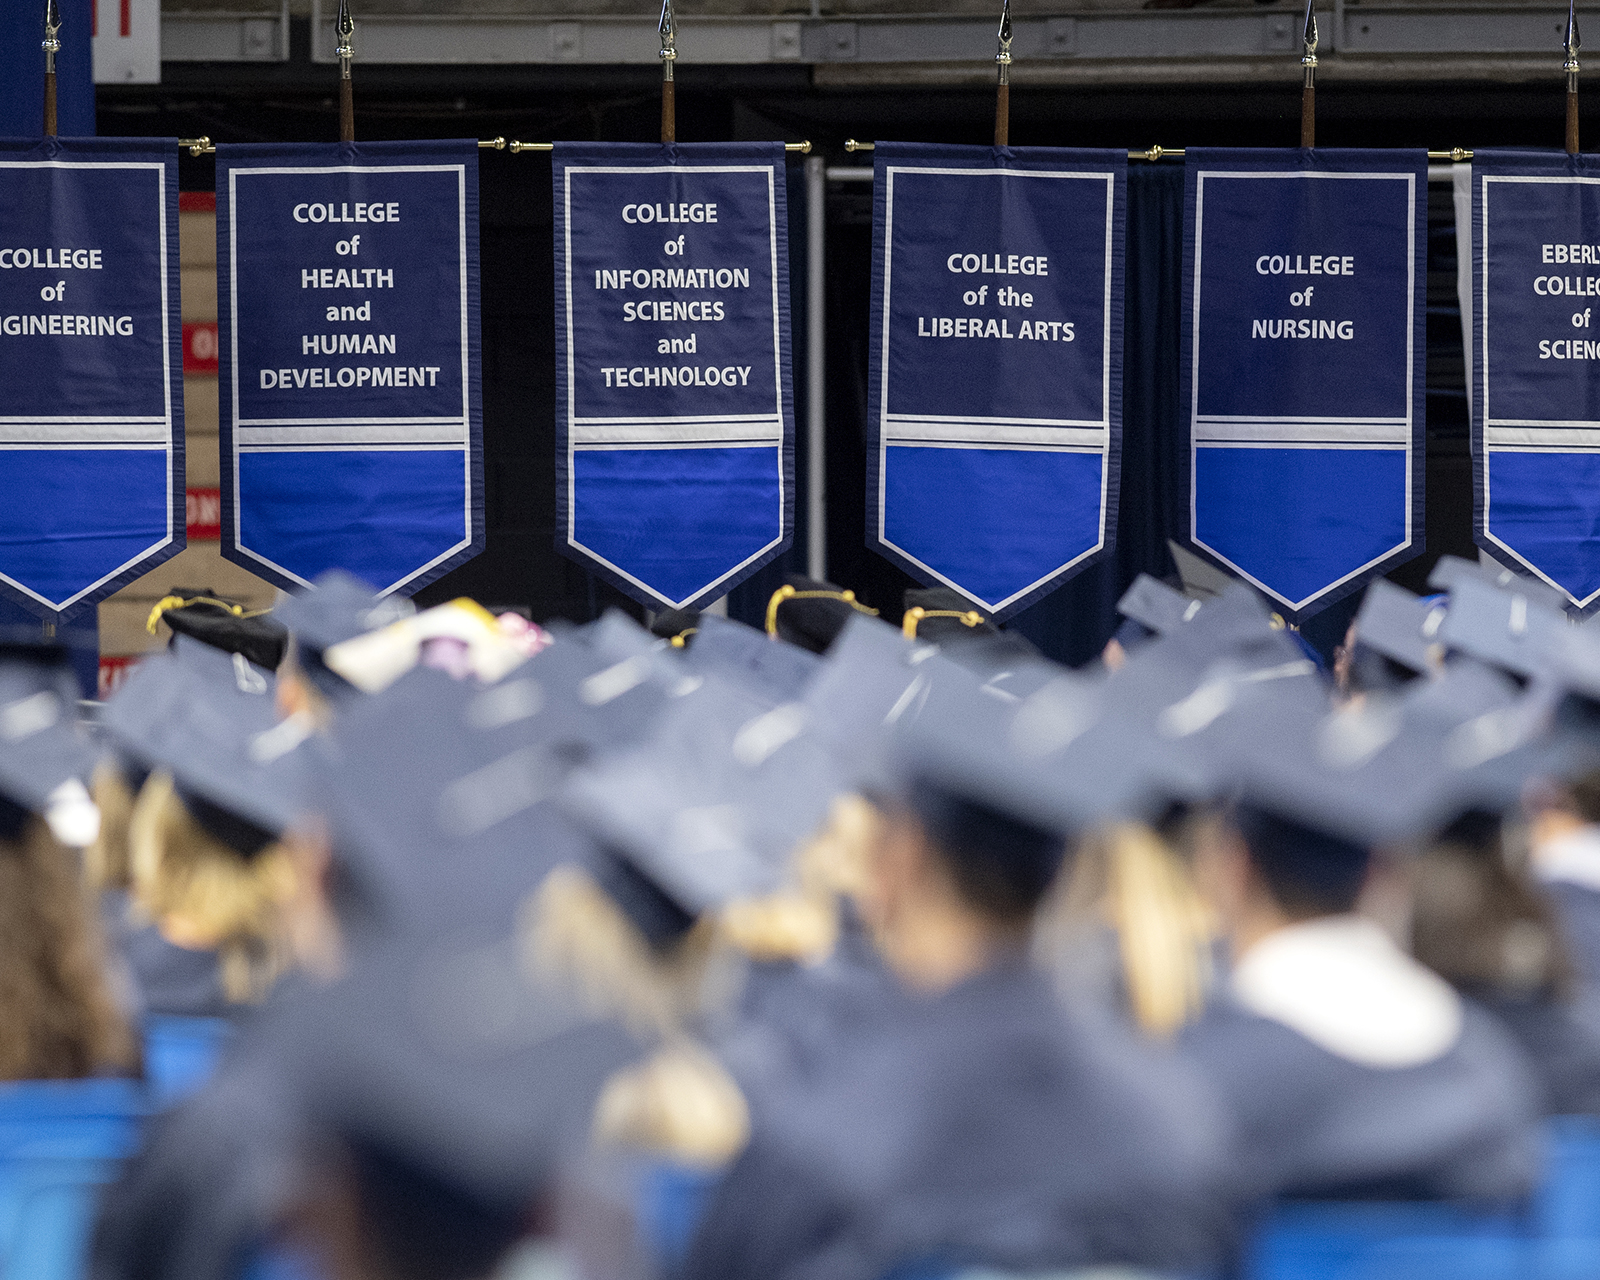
[867,142,1128,618]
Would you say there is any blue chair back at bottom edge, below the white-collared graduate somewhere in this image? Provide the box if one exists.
[1245,1202,1533,1280]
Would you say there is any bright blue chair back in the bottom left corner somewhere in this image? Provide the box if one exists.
[0,1080,147,1280]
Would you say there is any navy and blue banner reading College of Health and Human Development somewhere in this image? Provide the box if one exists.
[216,141,483,595]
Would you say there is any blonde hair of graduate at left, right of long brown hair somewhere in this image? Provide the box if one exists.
[128,773,294,1003]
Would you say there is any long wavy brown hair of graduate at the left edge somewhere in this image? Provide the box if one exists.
[0,818,139,1080]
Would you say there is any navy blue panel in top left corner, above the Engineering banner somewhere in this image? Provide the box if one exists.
[0,0,94,138]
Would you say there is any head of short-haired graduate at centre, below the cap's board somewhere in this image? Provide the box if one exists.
[862,778,1066,989]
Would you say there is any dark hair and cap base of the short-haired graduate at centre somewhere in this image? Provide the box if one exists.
[907,779,1067,923]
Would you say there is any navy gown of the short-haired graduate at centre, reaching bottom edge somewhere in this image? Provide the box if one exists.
[685,960,1229,1280]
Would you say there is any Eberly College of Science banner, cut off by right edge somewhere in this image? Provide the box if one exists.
[1470,150,1600,614]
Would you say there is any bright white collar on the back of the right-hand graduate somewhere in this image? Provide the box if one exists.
[1232,915,1461,1067]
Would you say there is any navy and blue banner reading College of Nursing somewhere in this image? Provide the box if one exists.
[1179,147,1427,621]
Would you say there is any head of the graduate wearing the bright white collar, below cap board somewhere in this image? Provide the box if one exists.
[1195,803,1371,950]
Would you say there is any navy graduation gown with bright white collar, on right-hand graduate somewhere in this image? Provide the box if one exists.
[1182,917,1539,1200]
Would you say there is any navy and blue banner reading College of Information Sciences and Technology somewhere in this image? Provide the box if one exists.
[554,142,794,608]
